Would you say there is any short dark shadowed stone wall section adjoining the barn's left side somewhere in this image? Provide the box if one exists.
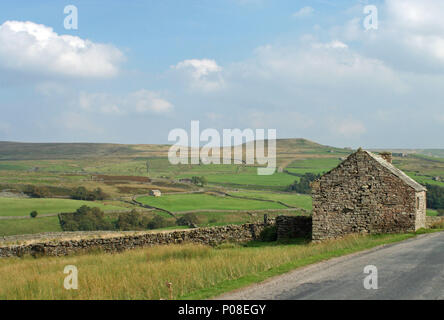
[276,216,312,240]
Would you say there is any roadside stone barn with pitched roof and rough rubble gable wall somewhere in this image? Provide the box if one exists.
[312,148,427,240]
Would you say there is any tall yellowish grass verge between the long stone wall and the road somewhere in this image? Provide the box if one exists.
[0,230,436,300]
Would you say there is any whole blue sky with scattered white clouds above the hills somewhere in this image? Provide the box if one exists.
[0,0,444,148]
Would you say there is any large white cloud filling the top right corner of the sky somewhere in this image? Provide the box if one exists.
[330,0,444,73]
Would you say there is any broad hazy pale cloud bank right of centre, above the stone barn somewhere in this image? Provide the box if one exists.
[238,40,407,94]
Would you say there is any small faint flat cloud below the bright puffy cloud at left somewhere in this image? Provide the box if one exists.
[76,89,174,115]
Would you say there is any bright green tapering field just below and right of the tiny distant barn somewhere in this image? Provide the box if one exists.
[137,194,285,212]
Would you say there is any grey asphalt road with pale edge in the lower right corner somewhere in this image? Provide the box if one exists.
[216,232,444,300]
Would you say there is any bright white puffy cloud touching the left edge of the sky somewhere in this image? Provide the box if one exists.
[0,21,124,77]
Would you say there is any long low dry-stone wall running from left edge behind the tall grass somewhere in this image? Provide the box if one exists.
[0,223,264,257]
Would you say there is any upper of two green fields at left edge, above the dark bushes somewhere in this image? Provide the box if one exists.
[0,198,125,216]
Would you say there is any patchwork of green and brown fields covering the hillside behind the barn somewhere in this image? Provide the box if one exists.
[0,139,444,236]
